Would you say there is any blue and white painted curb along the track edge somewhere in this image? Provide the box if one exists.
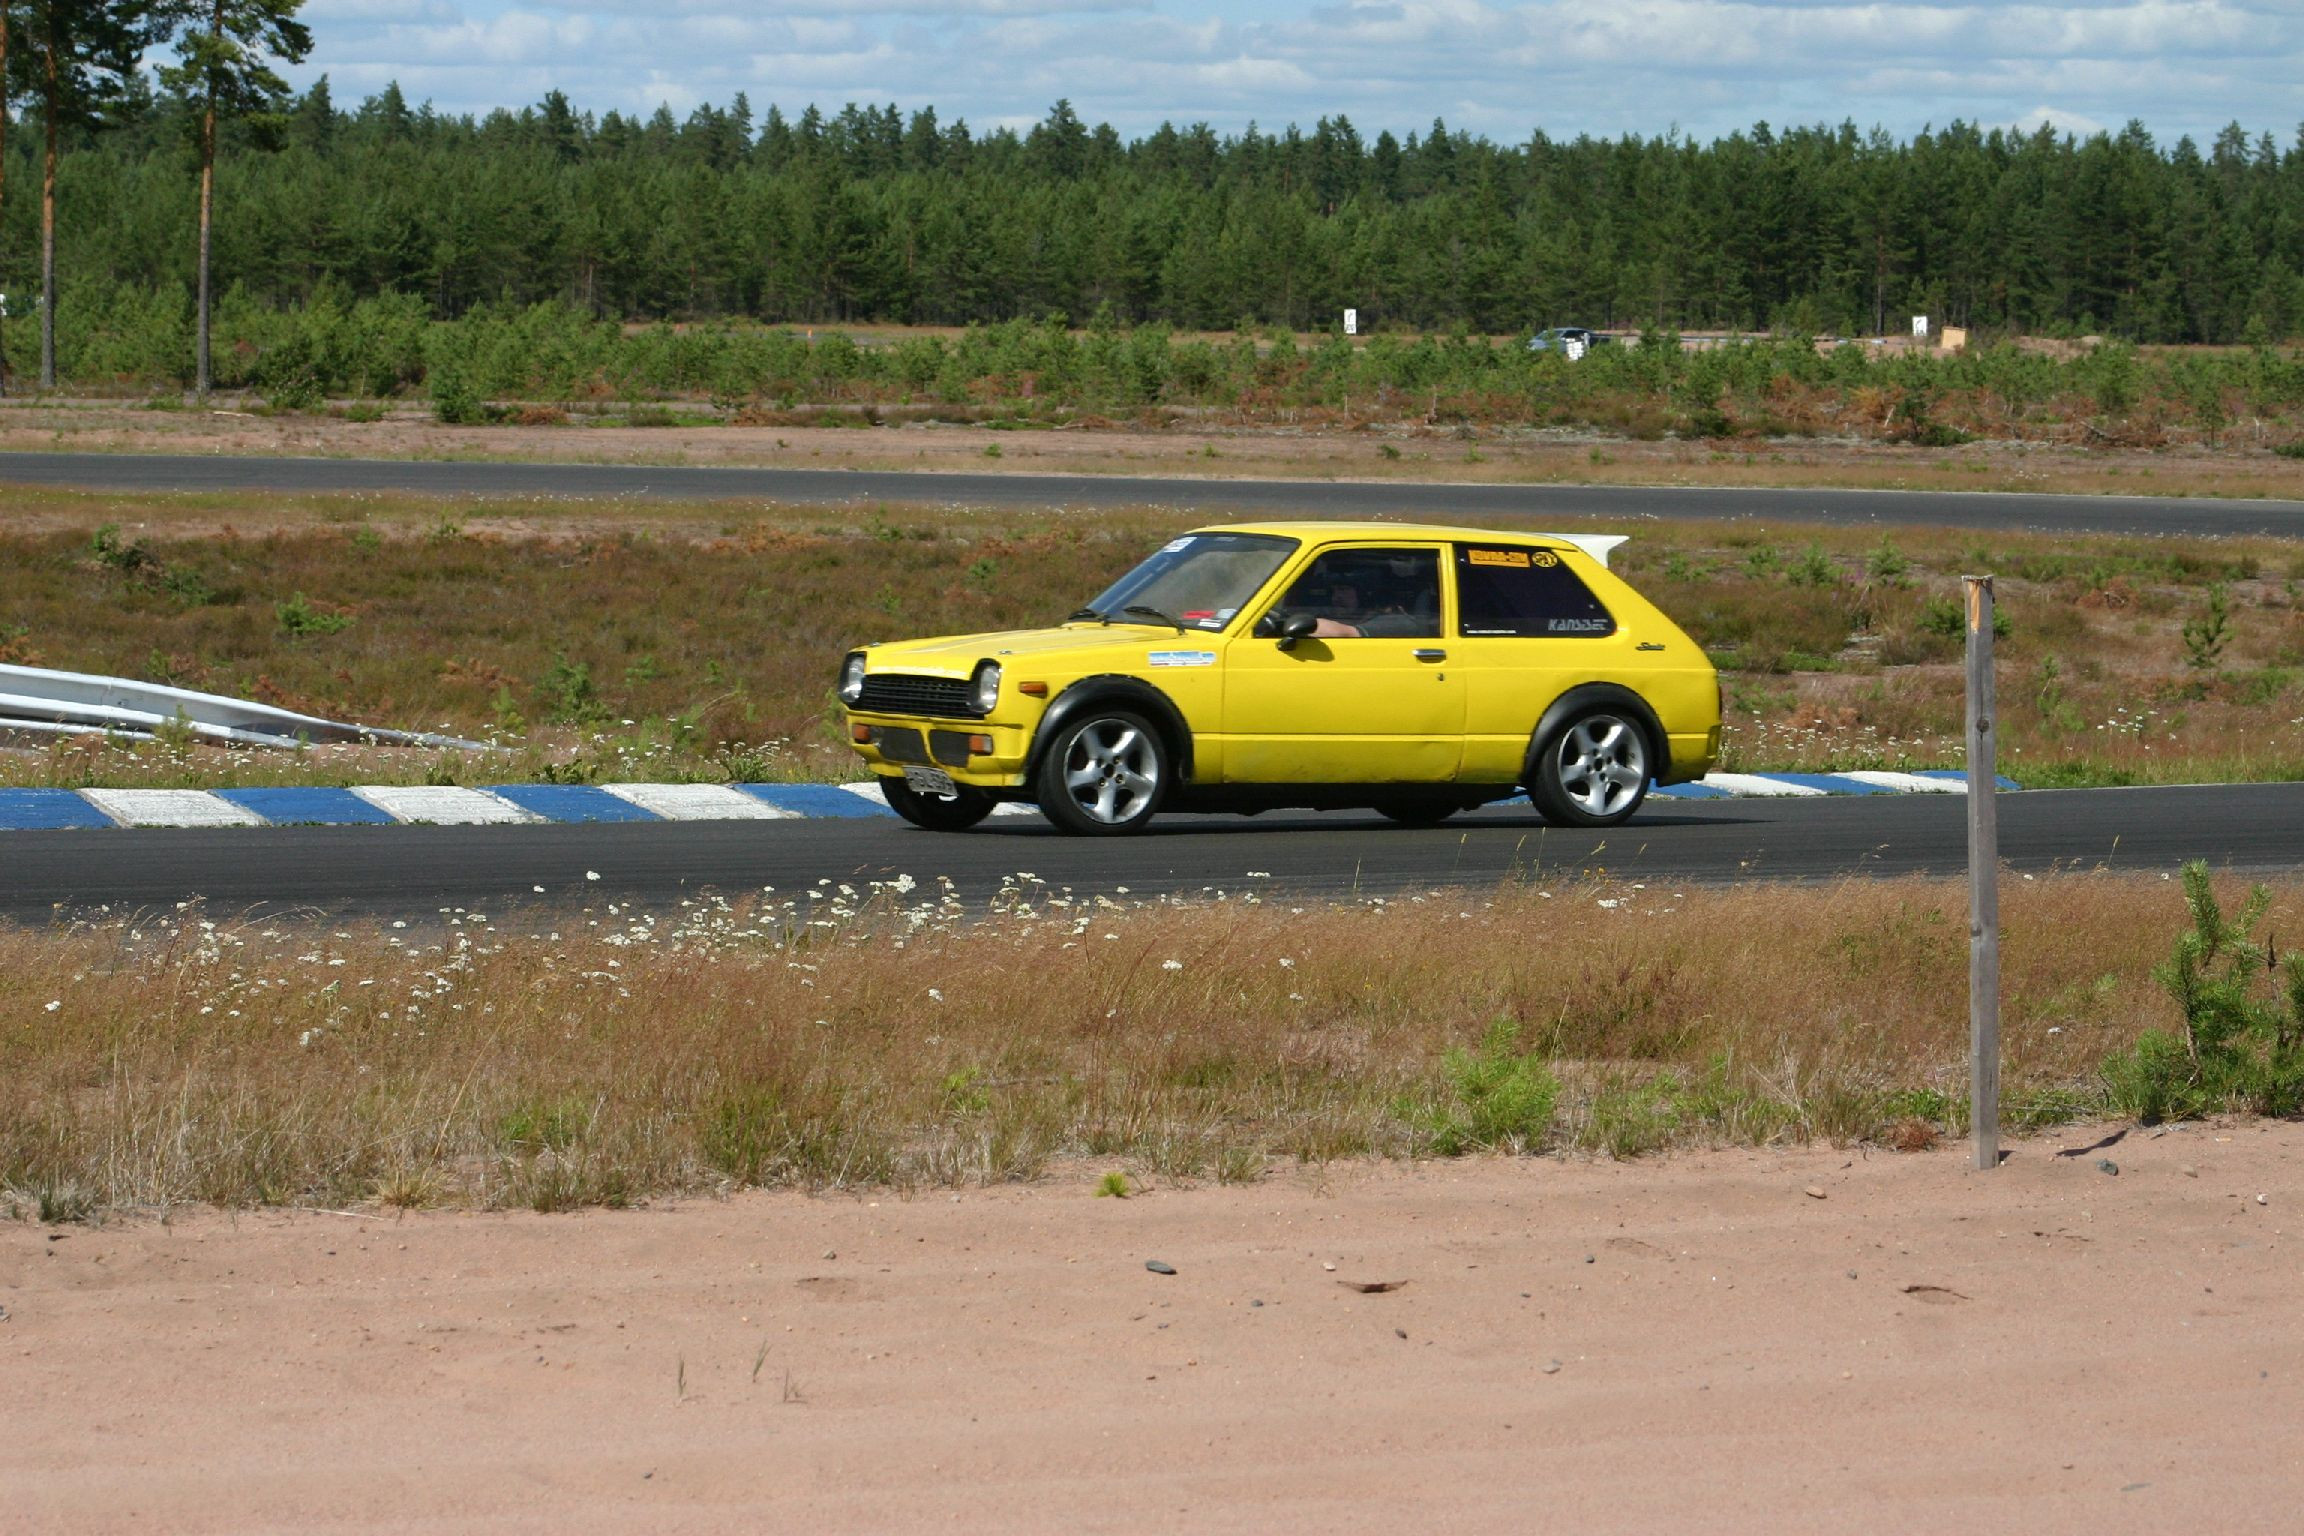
[0,769,2016,831]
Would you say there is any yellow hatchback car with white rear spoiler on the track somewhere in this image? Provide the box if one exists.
[839,523,1721,834]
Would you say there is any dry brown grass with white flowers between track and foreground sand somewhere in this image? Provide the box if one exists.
[0,875,2230,1214]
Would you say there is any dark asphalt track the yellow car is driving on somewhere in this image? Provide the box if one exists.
[0,785,2304,923]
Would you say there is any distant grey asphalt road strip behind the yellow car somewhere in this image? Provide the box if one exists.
[0,454,2304,537]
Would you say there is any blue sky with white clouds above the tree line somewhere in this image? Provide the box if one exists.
[290,0,2304,145]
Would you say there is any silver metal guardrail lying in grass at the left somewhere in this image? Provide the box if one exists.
[0,663,486,751]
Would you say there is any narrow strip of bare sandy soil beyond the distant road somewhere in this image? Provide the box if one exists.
[0,401,2304,497]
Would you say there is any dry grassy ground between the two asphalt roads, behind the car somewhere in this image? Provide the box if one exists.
[0,491,2304,788]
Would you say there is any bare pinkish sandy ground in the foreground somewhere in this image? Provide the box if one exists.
[0,1121,2304,1531]
